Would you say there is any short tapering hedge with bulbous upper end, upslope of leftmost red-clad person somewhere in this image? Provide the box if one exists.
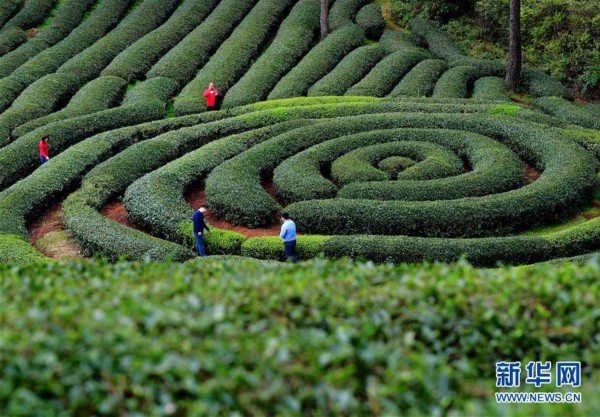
[13,76,127,138]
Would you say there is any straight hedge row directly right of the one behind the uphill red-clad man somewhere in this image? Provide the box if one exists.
[223,0,319,108]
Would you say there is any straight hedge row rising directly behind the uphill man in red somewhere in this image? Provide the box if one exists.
[175,0,293,115]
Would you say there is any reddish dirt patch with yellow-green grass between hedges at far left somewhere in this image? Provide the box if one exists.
[27,204,83,261]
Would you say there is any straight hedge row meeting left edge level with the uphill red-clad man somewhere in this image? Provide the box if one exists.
[0,0,129,111]
